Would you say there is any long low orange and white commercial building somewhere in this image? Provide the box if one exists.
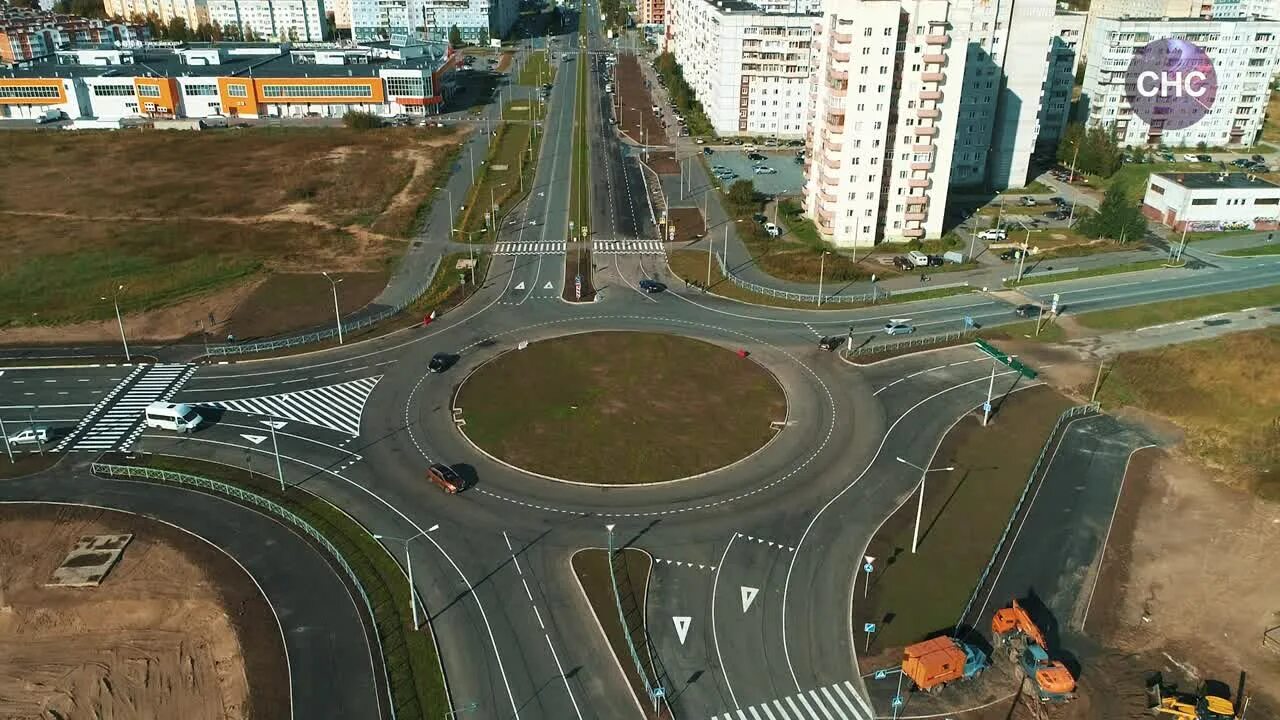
[0,44,449,122]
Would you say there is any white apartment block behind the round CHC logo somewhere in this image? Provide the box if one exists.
[1080,18,1280,146]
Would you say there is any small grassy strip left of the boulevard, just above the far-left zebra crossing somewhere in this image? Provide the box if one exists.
[457,123,541,235]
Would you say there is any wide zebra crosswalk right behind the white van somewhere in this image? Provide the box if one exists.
[54,364,196,452]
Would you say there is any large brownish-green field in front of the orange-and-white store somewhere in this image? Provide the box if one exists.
[0,128,462,325]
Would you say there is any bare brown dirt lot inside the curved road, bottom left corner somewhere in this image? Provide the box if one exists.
[0,506,289,720]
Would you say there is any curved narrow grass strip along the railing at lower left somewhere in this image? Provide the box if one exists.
[96,455,449,719]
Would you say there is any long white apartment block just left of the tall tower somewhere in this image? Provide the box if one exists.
[667,0,819,138]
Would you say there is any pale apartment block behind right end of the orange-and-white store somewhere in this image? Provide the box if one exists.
[349,0,520,42]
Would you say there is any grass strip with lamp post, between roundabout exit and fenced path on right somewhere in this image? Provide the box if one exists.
[854,388,1071,653]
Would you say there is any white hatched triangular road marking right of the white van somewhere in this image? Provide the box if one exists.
[193,375,383,436]
